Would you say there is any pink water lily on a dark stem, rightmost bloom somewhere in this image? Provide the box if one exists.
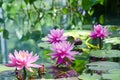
[91,24,111,39]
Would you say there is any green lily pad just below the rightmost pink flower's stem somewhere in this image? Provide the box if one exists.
[90,50,120,58]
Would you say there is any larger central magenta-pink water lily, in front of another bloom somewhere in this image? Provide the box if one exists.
[51,41,78,65]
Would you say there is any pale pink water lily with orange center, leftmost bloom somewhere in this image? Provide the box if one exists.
[6,50,41,72]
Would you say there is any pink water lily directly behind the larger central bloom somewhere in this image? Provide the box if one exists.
[47,29,67,43]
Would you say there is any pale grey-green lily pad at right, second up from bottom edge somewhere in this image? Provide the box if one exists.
[87,61,120,71]
